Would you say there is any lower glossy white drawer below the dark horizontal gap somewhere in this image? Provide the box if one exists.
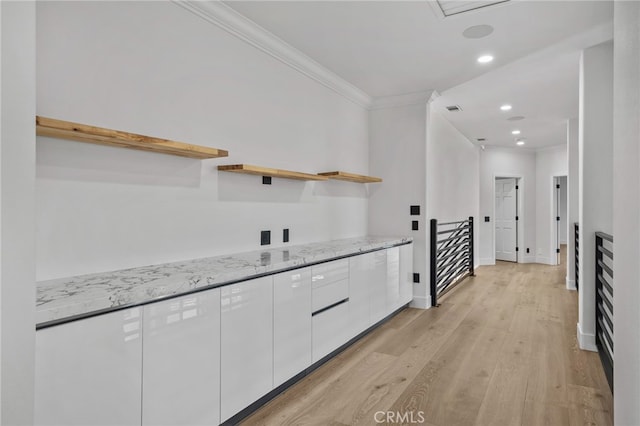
[311,301,349,362]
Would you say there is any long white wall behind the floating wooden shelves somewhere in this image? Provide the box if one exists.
[36,2,370,280]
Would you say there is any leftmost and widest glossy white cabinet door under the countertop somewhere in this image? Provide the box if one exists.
[34,308,142,426]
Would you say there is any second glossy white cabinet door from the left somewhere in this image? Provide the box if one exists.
[142,289,220,426]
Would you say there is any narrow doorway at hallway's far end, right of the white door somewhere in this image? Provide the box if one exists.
[551,175,569,265]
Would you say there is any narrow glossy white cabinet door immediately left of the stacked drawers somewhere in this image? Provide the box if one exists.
[273,268,311,388]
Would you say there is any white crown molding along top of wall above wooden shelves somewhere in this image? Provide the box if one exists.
[172,0,372,109]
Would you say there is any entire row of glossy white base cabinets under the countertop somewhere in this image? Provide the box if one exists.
[35,244,413,426]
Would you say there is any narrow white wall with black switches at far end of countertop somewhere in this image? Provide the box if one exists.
[369,100,431,308]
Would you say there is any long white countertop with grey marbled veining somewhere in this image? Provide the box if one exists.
[36,236,413,327]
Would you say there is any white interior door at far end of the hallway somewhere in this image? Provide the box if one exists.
[495,178,517,262]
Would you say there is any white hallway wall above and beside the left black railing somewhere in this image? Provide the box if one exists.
[426,110,480,269]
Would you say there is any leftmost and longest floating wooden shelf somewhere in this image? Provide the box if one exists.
[36,116,229,160]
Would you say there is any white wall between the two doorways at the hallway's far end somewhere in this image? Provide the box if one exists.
[536,145,567,265]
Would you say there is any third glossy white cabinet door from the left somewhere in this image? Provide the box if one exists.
[220,276,273,422]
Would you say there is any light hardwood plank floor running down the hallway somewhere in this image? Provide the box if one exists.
[243,248,613,426]
